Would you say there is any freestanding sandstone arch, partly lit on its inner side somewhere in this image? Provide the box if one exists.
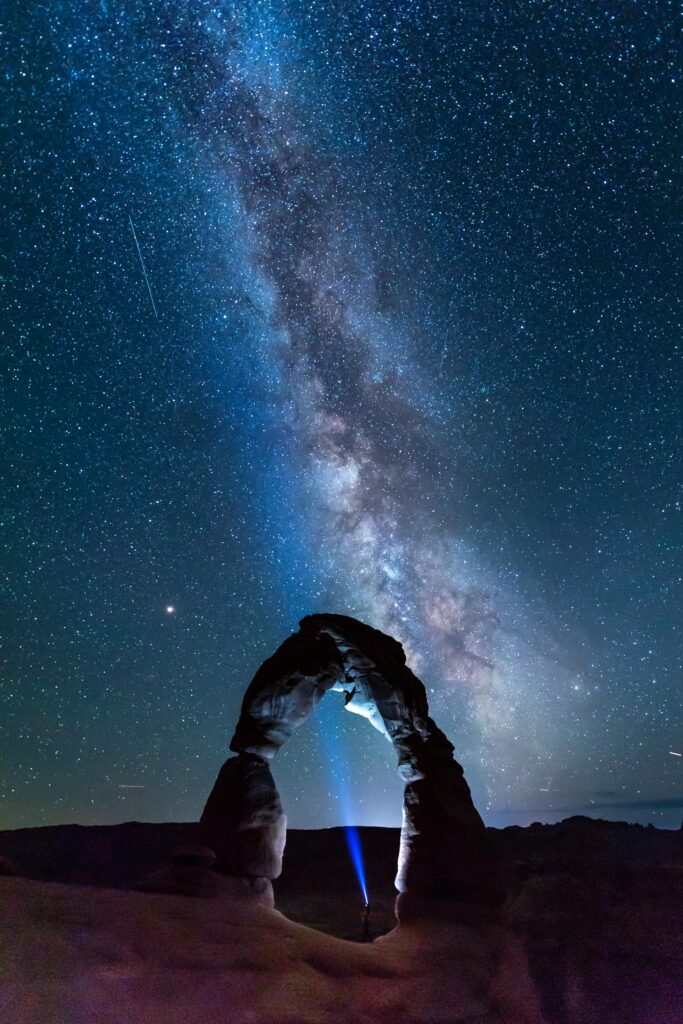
[201,614,498,903]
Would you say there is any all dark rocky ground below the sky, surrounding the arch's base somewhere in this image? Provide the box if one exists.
[0,818,683,1024]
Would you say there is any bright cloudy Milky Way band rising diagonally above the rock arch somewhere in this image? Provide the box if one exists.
[156,9,614,795]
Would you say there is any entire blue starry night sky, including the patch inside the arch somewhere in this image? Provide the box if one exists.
[0,0,683,828]
